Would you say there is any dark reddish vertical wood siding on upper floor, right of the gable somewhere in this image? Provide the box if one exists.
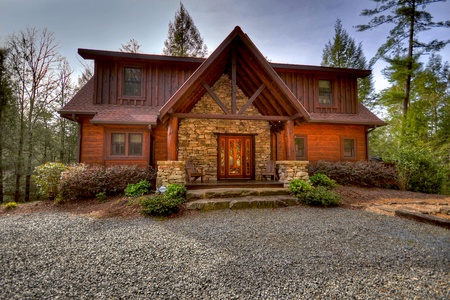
[278,71,358,114]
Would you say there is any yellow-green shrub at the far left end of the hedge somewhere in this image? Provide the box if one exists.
[33,162,67,199]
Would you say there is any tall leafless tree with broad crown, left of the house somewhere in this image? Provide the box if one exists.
[8,28,60,201]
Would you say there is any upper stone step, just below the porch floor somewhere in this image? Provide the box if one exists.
[186,187,289,202]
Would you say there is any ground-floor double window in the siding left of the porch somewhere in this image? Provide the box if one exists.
[111,133,143,156]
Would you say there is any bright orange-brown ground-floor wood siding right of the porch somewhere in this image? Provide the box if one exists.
[294,124,367,162]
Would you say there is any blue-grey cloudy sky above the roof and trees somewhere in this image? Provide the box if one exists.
[0,0,450,91]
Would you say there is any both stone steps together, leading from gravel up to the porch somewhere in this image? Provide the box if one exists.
[186,188,298,211]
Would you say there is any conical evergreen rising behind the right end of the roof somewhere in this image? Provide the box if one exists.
[321,19,373,105]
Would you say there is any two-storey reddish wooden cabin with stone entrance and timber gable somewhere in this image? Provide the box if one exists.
[59,27,385,181]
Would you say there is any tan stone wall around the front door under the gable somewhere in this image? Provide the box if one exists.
[178,75,270,182]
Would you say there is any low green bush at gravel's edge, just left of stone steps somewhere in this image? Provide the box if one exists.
[139,194,184,216]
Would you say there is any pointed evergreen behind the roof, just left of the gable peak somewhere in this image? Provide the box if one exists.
[163,2,208,57]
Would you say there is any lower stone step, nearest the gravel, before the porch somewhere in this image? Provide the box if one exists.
[186,195,299,211]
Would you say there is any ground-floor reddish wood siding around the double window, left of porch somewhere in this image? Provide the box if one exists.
[80,118,151,167]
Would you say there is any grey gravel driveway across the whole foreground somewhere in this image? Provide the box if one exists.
[0,206,450,299]
